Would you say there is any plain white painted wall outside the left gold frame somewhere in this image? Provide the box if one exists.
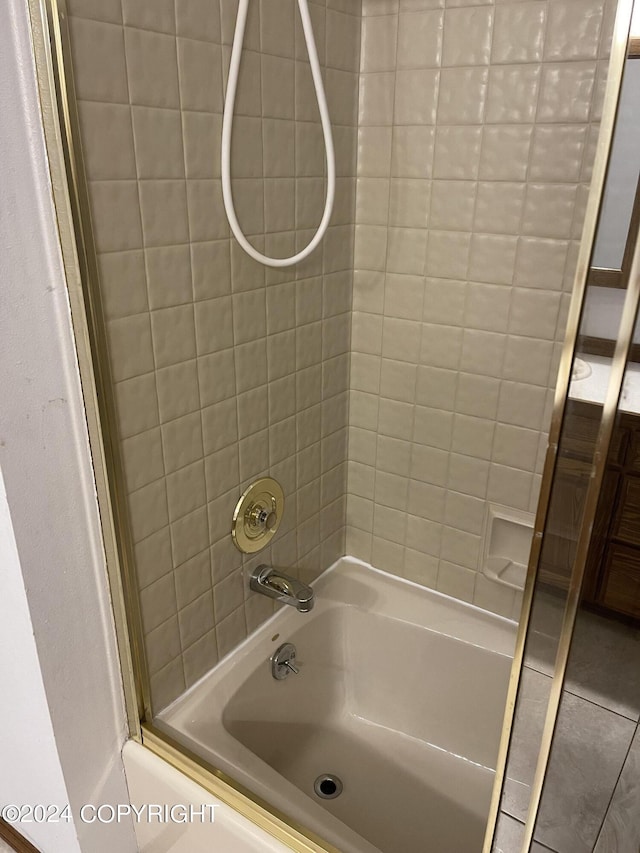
[0,0,138,853]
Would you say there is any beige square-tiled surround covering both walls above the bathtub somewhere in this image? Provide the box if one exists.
[63,0,615,708]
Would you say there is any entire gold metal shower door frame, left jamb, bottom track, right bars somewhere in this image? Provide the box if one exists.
[22,0,640,853]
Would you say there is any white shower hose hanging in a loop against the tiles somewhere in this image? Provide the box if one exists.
[222,0,336,267]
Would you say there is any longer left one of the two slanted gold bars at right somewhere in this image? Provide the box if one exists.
[482,0,633,853]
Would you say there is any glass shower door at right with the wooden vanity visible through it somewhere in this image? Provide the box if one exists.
[485,5,640,853]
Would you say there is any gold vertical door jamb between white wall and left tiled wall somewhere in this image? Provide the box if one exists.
[29,0,151,724]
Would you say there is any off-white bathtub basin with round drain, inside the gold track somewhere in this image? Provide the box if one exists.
[157,558,516,853]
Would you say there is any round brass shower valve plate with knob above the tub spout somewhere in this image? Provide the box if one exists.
[231,477,284,554]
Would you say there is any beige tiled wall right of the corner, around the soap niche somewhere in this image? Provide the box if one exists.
[347,0,615,616]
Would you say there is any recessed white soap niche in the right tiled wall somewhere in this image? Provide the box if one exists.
[480,504,534,590]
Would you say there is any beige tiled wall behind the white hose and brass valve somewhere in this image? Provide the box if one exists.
[68,0,360,708]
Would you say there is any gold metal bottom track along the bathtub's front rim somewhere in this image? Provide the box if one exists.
[142,723,341,853]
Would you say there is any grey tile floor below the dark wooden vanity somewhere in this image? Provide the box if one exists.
[495,592,640,853]
